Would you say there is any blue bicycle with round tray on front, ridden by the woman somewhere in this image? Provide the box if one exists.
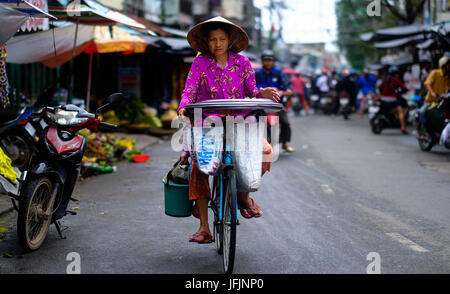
[185,99,283,274]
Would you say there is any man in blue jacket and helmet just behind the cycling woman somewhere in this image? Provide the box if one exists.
[255,50,295,152]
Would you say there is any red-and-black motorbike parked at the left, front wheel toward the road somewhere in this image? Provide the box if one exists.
[0,93,125,252]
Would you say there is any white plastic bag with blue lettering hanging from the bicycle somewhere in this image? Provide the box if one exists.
[191,127,224,176]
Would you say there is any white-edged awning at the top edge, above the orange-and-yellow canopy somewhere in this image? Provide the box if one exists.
[48,0,147,30]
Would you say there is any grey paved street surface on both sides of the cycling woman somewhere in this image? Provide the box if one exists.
[0,116,450,274]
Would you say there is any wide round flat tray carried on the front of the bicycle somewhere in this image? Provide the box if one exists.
[185,99,283,113]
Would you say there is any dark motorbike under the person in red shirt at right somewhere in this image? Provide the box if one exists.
[369,99,408,135]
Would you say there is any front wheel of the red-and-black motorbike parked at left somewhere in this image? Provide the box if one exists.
[17,177,55,252]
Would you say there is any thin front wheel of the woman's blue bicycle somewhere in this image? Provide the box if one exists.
[222,169,237,274]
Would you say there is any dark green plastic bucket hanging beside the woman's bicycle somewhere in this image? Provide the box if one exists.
[163,180,194,217]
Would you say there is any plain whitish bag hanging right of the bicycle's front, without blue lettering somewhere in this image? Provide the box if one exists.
[233,122,264,192]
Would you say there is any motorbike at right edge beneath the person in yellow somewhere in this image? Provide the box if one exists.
[415,91,450,152]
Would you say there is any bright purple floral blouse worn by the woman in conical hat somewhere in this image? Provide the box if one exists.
[178,51,259,110]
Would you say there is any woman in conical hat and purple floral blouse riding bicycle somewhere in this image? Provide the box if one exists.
[178,17,280,243]
